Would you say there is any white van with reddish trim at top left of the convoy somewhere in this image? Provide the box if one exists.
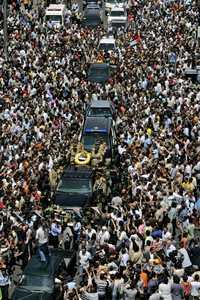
[45,4,67,27]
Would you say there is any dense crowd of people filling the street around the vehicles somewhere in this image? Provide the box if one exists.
[0,0,200,300]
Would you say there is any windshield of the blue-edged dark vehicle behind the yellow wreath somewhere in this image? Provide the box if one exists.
[82,132,109,150]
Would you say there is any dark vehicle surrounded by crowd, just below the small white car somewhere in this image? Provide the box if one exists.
[87,63,111,83]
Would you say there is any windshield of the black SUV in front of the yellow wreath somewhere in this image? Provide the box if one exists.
[58,178,91,194]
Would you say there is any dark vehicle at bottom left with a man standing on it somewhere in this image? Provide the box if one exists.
[11,249,75,300]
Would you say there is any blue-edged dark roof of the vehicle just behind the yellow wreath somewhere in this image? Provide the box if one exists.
[84,117,111,133]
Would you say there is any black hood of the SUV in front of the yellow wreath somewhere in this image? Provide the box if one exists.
[55,191,92,207]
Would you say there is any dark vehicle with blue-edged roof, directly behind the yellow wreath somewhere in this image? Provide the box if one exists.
[81,117,116,157]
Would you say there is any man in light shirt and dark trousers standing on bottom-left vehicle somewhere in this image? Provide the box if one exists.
[35,221,49,263]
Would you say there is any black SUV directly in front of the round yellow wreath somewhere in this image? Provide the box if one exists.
[55,166,93,209]
